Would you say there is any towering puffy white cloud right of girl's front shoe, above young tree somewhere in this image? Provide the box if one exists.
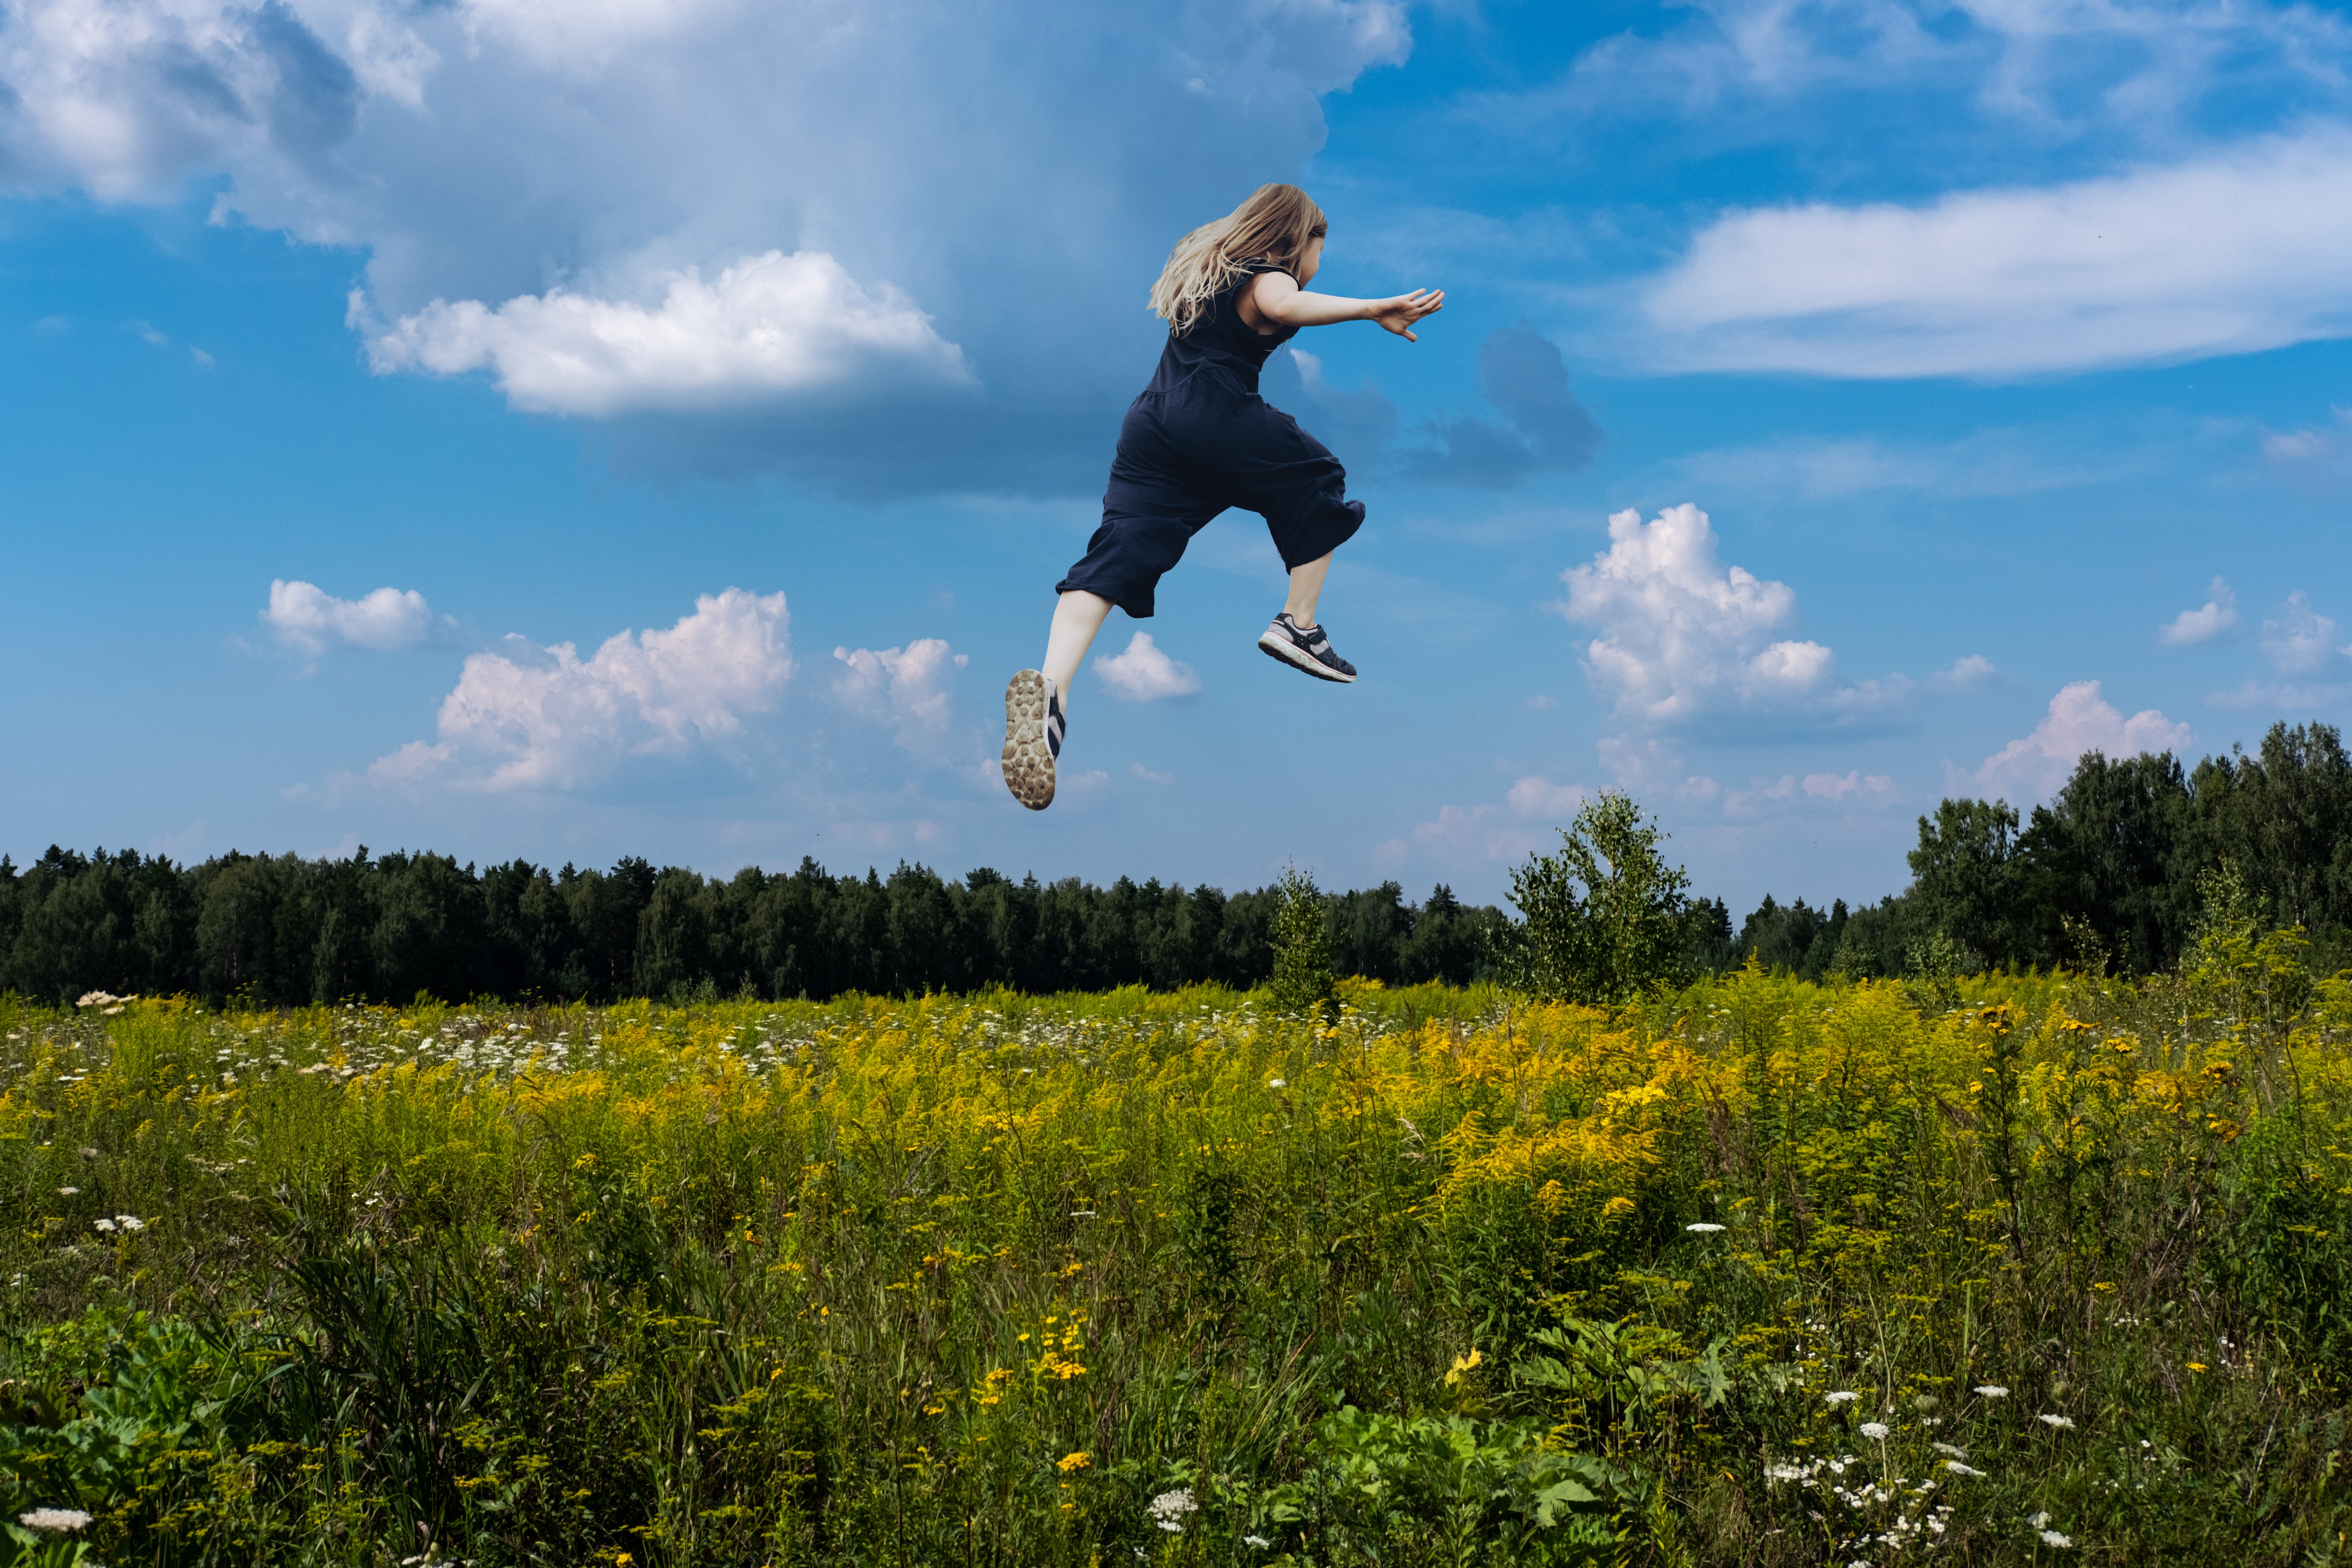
[1557,503,1832,726]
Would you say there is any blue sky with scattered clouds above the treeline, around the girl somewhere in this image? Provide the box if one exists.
[0,0,2352,915]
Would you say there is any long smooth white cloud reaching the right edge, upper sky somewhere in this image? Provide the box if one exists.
[1642,127,2352,378]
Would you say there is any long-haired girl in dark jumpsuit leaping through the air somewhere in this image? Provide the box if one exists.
[1004,186,1447,811]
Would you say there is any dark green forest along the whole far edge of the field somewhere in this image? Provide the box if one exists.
[0,724,2352,1004]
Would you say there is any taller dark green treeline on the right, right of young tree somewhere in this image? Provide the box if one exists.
[1734,724,2352,980]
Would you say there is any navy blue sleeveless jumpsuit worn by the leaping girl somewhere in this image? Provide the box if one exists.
[1054,261,1364,618]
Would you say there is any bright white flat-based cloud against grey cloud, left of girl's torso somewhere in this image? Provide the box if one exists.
[367,252,971,416]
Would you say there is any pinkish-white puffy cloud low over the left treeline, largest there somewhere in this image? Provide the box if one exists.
[367,588,793,790]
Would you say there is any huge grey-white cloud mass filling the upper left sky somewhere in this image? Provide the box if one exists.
[0,0,1411,487]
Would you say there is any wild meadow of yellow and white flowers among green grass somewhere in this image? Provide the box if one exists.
[0,938,2352,1568]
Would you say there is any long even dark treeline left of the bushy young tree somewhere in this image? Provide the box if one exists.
[0,846,1503,1004]
